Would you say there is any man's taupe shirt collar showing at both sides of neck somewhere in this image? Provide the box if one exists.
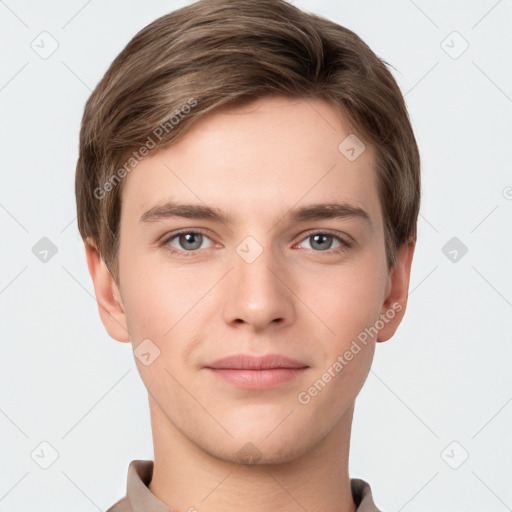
[107,460,381,512]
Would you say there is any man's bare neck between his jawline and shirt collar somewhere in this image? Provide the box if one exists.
[148,398,356,512]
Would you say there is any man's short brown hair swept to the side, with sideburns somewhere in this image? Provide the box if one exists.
[75,0,420,282]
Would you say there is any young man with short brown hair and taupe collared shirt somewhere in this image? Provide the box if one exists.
[76,0,420,512]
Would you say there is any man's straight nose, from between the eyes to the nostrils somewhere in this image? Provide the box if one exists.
[222,240,295,332]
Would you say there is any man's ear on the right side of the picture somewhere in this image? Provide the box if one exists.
[377,240,416,342]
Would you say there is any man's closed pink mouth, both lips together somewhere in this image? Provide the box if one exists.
[204,354,309,389]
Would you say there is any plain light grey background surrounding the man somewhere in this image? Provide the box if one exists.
[0,0,512,512]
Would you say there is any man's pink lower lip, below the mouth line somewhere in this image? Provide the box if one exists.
[204,368,307,389]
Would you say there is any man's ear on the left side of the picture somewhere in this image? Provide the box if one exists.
[84,239,130,342]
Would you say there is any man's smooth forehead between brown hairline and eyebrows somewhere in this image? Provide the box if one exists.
[121,98,380,228]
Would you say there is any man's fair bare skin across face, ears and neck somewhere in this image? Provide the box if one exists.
[86,97,414,512]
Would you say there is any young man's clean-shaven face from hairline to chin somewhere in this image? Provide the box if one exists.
[91,98,412,463]
